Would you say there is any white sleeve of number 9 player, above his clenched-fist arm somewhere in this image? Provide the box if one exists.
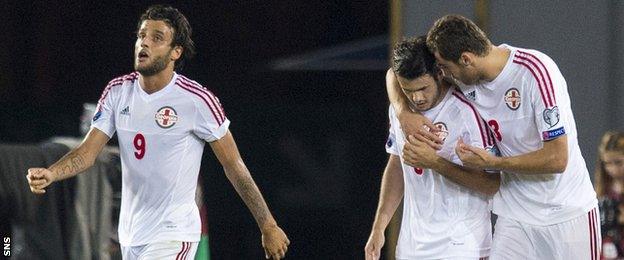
[91,80,123,138]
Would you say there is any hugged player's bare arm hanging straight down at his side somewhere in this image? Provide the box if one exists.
[364,155,404,260]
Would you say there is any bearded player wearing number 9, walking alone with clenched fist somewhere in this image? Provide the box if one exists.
[27,6,290,259]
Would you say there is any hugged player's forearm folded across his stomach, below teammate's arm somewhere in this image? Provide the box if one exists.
[433,157,500,196]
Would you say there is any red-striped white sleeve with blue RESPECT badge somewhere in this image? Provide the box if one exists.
[517,52,567,141]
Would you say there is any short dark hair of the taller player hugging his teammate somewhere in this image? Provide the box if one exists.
[427,15,491,62]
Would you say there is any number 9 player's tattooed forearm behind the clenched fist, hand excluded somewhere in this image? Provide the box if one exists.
[48,147,95,181]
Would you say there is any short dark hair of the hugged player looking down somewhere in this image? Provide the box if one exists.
[392,36,438,80]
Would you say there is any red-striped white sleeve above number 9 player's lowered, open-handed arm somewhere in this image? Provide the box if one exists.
[193,93,230,142]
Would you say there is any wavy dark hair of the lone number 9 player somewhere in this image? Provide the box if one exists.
[137,5,195,70]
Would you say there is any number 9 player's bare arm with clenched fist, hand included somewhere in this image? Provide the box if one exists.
[26,128,109,194]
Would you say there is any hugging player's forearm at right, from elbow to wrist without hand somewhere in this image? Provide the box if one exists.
[492,137,568,174]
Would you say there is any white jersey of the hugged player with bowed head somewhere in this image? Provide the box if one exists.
[386,89,493,259]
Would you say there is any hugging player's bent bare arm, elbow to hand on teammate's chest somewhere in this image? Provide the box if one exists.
[456,135,568,174]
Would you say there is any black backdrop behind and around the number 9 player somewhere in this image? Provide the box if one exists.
[0,0,389,259]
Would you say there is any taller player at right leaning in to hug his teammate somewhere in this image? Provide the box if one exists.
[388,15,601,259]
